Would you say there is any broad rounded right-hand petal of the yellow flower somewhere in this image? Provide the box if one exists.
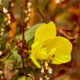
[52,36,72,64]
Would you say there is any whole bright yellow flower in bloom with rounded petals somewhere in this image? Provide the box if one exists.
[30,22,72,68]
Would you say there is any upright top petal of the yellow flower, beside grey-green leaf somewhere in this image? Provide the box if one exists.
[35,22,56,41]
